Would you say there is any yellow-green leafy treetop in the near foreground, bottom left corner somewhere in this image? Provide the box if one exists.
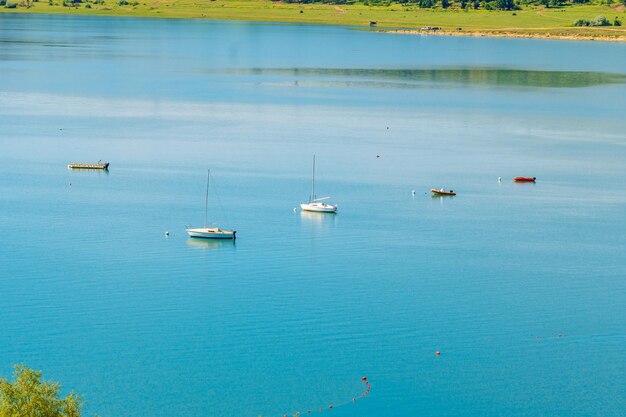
[0,365,83,417]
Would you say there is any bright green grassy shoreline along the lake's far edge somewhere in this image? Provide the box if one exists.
[0,0,626,42]
